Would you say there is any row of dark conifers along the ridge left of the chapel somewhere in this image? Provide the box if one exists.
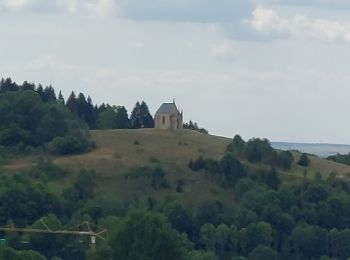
[0,78,154,129]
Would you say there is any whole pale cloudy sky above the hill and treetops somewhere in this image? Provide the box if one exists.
[0,0,350,144]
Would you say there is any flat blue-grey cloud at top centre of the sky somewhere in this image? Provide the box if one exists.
[118,0,254,22]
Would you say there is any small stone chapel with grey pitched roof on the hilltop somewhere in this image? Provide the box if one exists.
[154,100,183,129]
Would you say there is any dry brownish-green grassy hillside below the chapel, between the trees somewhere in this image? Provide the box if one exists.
[2,129,350,207]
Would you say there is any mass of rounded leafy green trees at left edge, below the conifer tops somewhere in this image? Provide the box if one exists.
[0,79,92,154]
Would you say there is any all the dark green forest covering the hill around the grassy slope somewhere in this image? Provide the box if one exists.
[0,79,350,260]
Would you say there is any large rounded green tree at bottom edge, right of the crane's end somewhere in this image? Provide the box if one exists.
[108,210,187,260]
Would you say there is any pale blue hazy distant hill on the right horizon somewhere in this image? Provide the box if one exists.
[271,142,350,158]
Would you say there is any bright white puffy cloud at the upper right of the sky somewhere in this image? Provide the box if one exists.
[251,7,350,43]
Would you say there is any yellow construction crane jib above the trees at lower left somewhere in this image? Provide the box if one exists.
[0,219,107,246]
